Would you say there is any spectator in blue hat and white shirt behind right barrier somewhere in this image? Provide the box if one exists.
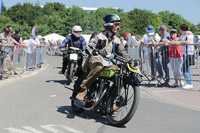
[141,25,163,79]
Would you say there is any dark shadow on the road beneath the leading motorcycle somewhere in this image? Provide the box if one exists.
[57,106,108,125]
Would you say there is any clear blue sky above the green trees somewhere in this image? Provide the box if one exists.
[2,0,200,25]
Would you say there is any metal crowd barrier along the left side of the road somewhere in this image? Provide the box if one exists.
[0,46,47,75]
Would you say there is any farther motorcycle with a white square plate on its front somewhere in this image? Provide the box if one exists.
[65,47,80,85]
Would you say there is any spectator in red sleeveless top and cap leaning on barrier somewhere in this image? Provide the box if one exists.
[168,29,184,87]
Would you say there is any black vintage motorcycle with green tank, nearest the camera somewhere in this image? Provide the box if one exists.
[70,56,143,126]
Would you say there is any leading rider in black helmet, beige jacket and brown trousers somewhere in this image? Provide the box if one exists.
[76,14,130,101]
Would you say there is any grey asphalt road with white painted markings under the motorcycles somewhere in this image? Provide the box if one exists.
[0,56,200,133]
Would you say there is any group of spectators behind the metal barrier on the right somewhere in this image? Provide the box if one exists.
[120,24,200,89]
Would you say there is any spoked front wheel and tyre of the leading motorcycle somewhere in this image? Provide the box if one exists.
[106,81,140,127]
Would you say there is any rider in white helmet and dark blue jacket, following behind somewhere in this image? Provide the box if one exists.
[59,25,86,75]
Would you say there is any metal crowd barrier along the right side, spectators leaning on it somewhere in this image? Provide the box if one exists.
[128,44,200,90]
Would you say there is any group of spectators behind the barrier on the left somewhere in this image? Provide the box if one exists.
[0,26,49,80]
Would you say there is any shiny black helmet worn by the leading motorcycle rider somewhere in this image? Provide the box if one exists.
[103,14,121,30]
